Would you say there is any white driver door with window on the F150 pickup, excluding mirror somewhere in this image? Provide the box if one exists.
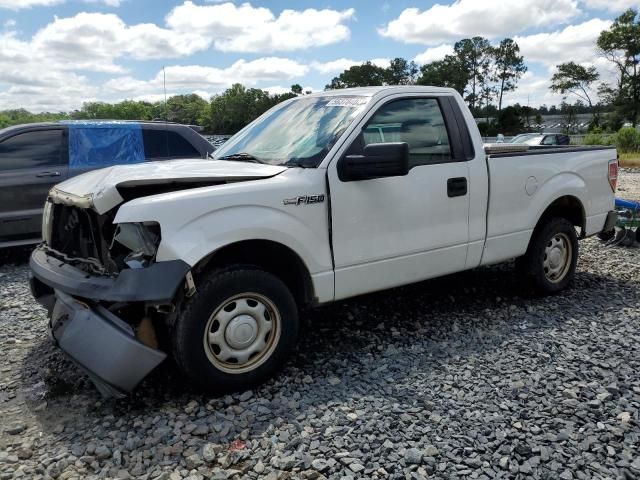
[328,97,473,299]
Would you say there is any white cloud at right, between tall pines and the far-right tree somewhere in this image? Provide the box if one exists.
[514,18,611,66]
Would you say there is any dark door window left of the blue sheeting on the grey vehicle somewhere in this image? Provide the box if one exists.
[0,129,62,170]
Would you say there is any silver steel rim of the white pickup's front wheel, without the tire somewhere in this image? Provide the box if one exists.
[203,293,282,374]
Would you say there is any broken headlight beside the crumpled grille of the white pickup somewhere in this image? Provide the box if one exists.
[111,222,160,268]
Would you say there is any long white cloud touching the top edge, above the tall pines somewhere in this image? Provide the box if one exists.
[379,0,580,45]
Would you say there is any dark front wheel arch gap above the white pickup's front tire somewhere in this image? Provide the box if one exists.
[192,239,316,307]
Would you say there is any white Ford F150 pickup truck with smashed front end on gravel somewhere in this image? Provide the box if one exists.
[30,86,618,395]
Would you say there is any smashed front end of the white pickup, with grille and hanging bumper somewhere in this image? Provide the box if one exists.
[30,195,192,397]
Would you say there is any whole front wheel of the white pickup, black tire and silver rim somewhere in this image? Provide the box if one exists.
[172,266,298,393]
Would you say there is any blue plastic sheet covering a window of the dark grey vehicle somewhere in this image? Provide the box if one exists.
[68,121,144,168]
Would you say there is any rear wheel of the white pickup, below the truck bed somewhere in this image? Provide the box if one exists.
[516,217,578,294]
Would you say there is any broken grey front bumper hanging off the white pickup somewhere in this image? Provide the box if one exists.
[29,247,189,397]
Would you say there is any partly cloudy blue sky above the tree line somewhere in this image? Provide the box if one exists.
[0,0,640,112]
